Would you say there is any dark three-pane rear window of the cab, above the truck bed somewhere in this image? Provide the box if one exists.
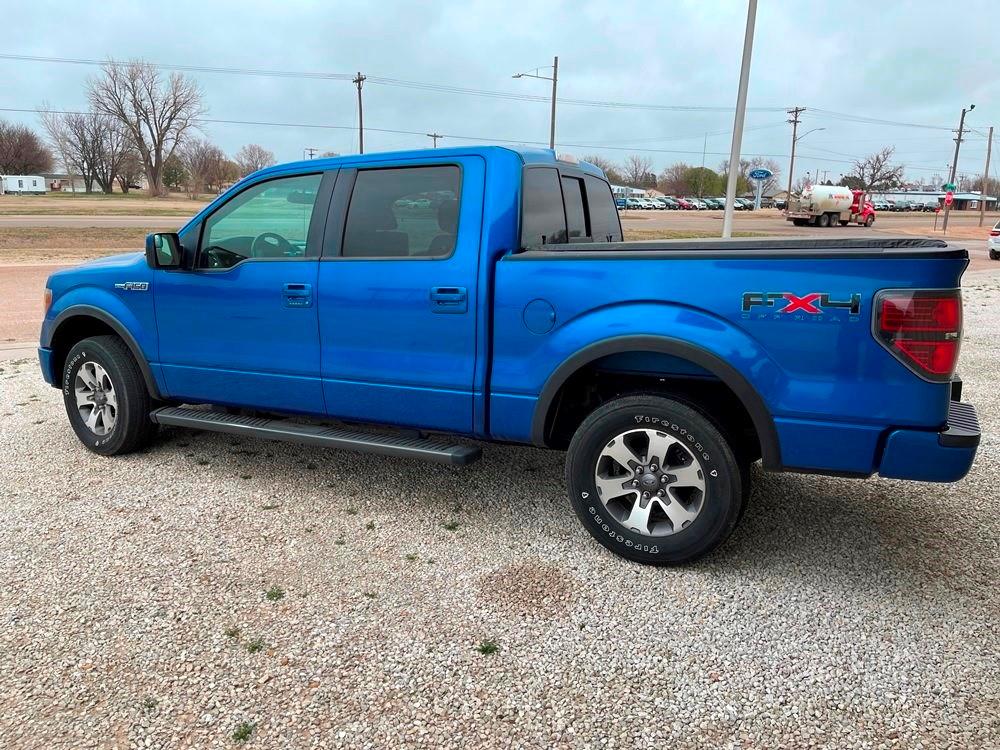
[521,167,622,248]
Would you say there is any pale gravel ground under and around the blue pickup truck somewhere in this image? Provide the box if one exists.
[0,274,1000,749]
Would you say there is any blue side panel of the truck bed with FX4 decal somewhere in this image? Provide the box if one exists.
[490,253,966,472]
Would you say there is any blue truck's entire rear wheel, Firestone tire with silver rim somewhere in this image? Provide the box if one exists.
[566,395,743,565]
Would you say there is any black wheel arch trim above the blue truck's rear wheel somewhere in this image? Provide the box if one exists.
[531,335,781,470]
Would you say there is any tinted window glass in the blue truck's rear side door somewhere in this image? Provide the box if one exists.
[342,165,462,258]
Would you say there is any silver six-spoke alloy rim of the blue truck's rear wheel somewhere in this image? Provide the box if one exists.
[594,429,705,536]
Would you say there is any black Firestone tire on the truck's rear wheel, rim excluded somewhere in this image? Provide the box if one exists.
[566,395,749,565]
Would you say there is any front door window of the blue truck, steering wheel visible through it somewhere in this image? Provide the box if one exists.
[198,174,323,268]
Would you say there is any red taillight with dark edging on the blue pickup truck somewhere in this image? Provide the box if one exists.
[875,289,962,381]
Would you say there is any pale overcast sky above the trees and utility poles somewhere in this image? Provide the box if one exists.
[0,0,1000,186]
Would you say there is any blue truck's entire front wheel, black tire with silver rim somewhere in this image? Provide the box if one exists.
[63,336,156,456]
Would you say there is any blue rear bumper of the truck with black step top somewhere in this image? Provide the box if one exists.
[878,401,980,482]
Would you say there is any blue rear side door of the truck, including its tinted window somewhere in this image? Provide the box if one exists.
[318,156,485,433]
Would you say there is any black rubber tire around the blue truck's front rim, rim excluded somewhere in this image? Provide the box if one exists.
[62,336,156,456]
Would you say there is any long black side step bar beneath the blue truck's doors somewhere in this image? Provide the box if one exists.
[149,406,482,466]
